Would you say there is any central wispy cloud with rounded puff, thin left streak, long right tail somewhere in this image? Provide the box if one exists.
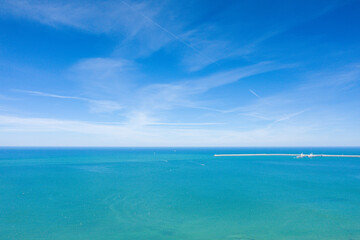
[17,58,292,126]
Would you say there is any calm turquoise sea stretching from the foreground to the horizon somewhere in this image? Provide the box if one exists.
[0,148,360,240]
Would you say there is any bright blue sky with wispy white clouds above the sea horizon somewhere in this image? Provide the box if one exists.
[0,0,360,146]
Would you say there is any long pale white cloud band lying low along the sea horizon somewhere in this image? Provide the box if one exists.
[0,115,354,146]
